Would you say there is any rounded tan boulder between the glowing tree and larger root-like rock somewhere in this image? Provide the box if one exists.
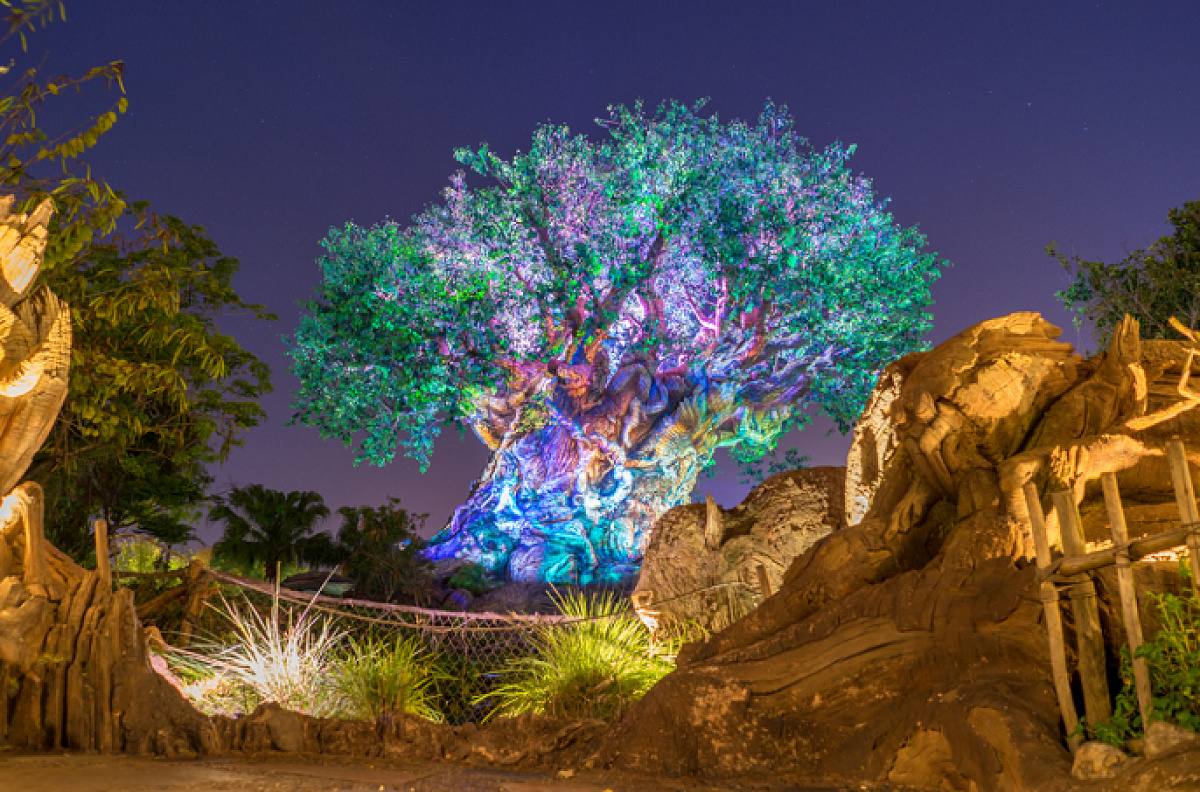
[632,467,846,631]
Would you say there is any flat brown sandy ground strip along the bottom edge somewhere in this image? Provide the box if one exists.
[0,754,850,792]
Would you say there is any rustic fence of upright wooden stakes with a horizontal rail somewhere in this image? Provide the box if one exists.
[1025,438,1200,751]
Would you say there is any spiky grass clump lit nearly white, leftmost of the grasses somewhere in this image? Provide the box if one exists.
[170,595,346,718]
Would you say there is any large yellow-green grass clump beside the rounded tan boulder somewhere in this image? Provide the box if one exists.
[476,590,672,720]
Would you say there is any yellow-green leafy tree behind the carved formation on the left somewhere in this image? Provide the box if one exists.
[32,204,272,559]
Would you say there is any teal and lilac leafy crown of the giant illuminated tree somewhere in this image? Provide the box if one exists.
[292,102,940,467]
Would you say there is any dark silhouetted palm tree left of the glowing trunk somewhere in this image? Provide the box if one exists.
[209,484,332,582]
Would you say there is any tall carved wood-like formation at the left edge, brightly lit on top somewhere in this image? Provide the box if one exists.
[0,197,218,755]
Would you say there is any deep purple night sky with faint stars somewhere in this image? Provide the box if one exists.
[23,0,1200,541]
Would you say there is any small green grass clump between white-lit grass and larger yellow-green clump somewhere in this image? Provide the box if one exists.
[335,635,445,725]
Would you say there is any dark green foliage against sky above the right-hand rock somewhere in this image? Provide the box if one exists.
[1046,200,1200,344]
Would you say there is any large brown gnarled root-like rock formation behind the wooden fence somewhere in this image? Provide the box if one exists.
[605,313,1200,792]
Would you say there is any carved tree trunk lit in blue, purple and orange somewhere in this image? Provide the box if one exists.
[426,362,744,583]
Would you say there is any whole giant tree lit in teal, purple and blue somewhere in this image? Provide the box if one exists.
[292,103,938,582]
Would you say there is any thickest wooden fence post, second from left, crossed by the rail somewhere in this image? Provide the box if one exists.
[1051,491,1112,724]
